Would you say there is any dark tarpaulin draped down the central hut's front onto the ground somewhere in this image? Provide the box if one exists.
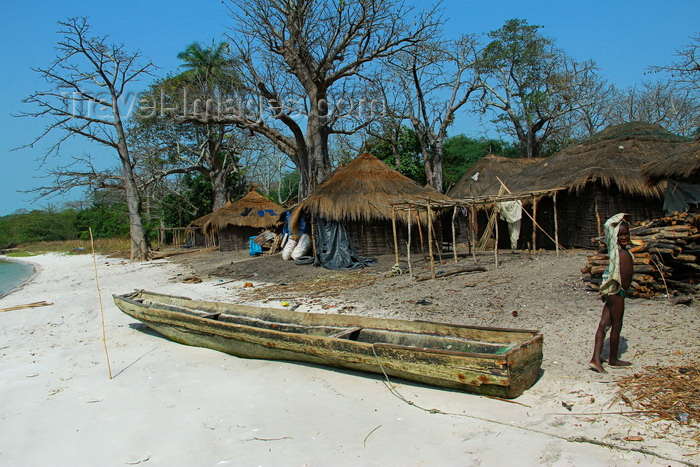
[314,219,377,269]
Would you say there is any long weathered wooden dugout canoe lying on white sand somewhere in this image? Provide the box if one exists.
[114,291,542,398]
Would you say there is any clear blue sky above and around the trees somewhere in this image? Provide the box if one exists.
[0,0,700,216]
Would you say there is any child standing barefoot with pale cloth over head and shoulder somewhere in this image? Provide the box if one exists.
[590,213,634,373]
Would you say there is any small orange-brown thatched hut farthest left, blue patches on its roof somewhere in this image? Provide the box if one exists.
[203,190,283,251]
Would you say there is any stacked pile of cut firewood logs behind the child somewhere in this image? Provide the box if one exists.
[581,213,700,298]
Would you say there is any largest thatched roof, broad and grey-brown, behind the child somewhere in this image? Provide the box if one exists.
[521,122,687,197]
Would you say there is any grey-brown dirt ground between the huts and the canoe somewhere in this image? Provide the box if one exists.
[172,245,700,381]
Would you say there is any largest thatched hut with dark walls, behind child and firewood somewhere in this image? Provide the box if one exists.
[520,122,687,248]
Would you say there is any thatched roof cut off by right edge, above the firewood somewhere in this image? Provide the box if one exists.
[642,136,700,183]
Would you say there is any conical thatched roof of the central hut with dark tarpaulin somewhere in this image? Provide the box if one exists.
[292,154,449,225]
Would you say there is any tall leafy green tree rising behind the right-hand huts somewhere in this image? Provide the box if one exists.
[477,19,595,157]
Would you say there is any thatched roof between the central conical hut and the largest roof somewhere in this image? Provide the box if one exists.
[447,154,542,199]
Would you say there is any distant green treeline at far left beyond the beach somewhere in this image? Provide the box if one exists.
[0,204,129,246]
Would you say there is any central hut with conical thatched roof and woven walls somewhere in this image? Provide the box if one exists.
[291,154,449,255]
